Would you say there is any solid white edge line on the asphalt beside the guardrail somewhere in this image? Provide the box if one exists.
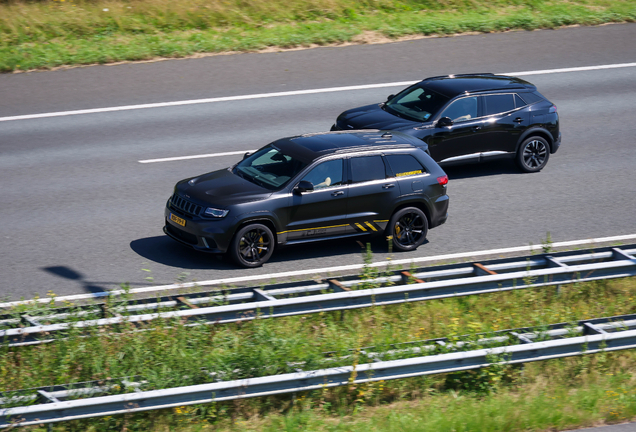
[0,234,636,308]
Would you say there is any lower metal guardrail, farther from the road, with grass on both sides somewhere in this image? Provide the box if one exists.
[0,315,636,428]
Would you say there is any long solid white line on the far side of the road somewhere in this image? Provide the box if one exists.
[0,63,636,122]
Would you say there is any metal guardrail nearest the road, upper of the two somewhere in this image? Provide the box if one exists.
[0,245,636,346]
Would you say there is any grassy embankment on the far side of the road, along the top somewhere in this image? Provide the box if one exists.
[0,0,636,72]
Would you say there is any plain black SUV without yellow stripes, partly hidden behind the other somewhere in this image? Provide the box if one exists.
[331,74,561,172]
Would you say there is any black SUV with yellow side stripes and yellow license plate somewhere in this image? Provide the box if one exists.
[164,130,448,267]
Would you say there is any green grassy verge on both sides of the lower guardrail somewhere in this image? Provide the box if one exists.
[0,248,636,431]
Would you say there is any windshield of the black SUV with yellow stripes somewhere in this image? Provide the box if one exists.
[232,145,306,190]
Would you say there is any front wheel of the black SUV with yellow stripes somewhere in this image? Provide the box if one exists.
[229,224,274,268]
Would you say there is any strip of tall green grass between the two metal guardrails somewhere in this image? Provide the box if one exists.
[0,278,636,406]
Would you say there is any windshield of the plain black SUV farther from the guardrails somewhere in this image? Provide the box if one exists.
[383,87,449,122]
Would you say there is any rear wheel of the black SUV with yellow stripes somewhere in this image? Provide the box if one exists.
[387,207,428,252]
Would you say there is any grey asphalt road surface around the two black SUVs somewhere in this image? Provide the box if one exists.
[0,24,636,300]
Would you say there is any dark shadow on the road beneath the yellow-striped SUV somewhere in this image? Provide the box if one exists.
[130,236,402,270]
